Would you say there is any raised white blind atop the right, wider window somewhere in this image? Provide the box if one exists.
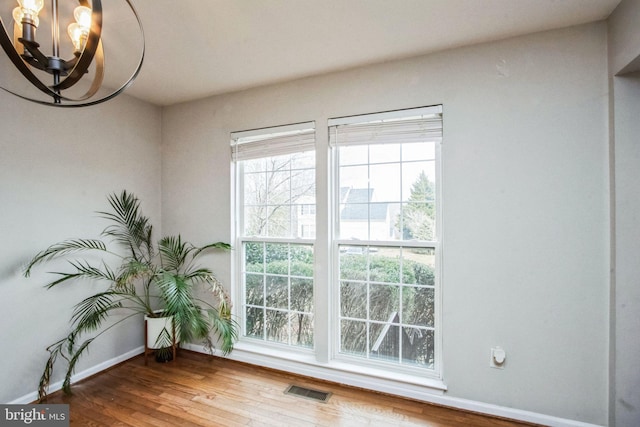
[329,106,442,147]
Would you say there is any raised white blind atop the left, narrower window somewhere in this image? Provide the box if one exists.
[231,122,316,161]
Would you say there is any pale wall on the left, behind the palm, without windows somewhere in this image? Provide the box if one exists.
[0,92,161,403]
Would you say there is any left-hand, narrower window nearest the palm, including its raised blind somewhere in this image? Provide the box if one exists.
[232,123,315,348]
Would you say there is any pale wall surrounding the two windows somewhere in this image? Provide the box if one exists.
[162,23,609,424]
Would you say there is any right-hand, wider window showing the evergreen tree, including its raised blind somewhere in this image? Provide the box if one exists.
[330,107,442,371]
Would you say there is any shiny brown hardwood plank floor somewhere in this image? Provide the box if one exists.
[41,350,531,427]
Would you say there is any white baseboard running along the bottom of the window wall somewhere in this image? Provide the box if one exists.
[183,344,602,427]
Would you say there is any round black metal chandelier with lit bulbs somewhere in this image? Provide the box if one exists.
[0,0,144,107]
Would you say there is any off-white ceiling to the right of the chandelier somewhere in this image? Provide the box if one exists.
[124,0,620,105]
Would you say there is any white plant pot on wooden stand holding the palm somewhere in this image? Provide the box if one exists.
[144,310,180,365]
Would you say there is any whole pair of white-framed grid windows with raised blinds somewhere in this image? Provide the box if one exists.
[231,106,442,387]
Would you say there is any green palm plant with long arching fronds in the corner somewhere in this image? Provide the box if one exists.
[24,191,237,400]
